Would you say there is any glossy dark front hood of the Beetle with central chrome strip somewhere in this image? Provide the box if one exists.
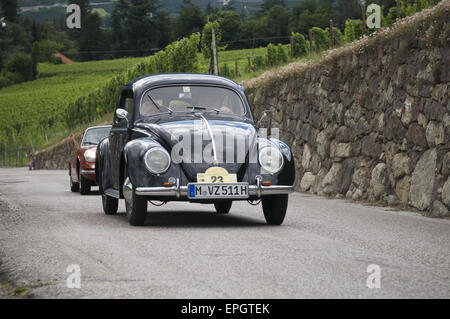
[136,113,256,181]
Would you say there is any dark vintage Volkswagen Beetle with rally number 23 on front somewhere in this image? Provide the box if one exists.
[95,74,295,226]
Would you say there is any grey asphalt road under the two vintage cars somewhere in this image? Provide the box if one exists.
[0,168,450,298]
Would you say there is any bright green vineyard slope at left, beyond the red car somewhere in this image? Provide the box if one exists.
[0,58,142,161]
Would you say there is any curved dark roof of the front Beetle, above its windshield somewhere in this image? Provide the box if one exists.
[127,73,243,91]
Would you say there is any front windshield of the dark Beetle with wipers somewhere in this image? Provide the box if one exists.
[139,85,245,116]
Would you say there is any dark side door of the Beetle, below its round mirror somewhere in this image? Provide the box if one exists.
[109,88,133,190]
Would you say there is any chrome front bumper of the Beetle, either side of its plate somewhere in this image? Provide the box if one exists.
[132,176,294,198]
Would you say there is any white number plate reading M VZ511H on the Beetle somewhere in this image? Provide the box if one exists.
[188,183,248,199]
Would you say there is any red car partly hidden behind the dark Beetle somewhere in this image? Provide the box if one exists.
[69,125,111,195]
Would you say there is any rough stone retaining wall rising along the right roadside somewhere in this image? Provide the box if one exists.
[243,0,450,216]
